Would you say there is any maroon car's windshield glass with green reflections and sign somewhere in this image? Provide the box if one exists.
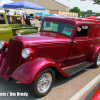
[42,21,73,36]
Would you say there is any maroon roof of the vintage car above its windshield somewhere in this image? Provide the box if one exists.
[44,16,100,24]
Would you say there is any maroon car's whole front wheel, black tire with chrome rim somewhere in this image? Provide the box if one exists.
[30,68,55,97]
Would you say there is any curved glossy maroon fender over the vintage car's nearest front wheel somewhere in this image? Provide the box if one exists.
[11,58,69,84]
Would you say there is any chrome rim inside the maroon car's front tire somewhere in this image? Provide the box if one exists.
[37,73,52,93]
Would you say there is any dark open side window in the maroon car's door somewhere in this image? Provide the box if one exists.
[76,26,89,37]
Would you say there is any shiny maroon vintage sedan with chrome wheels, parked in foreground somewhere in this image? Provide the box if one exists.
[0,17,100,97]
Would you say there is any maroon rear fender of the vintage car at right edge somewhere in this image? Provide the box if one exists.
[88,45,100,63]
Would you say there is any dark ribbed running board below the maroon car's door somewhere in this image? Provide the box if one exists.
[62,62,94,75]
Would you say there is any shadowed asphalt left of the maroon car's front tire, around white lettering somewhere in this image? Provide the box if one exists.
[0,78,36,100]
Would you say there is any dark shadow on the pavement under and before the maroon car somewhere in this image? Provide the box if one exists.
[0,65,94,100]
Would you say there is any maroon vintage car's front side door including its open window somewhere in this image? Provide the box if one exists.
[66,26,89,63]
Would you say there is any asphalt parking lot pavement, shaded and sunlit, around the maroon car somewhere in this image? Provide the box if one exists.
[0,67,100,100]
